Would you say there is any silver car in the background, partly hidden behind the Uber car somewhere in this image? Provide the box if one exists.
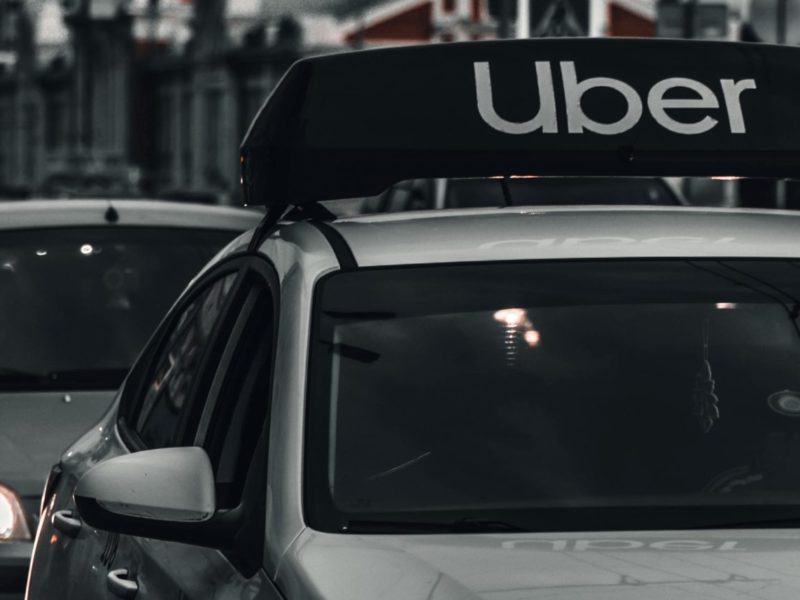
[0,200,260,593]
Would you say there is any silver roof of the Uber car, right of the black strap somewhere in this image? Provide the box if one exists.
[324,206,800,267]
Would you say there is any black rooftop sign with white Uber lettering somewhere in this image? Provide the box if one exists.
[242,38,800,202]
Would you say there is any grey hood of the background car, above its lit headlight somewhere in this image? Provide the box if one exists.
[0,390,116,498]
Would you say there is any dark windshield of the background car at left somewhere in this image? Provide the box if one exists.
[0,227,234,391]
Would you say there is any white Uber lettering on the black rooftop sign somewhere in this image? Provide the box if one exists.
[473,61,757,135]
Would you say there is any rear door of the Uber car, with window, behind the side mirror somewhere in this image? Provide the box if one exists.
[28,260,246,600]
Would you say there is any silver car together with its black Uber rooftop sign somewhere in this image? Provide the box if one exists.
[27,39,800,600]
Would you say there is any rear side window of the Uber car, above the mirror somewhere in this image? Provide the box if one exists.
[134,273,236,448]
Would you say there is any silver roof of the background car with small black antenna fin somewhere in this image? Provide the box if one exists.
[0,199,263,231]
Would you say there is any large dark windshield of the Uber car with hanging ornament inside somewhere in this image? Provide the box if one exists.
[306,260,800,531]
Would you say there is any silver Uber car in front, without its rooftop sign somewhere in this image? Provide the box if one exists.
[28,203,800,600]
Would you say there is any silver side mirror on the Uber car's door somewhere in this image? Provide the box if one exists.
[75,447,216,541]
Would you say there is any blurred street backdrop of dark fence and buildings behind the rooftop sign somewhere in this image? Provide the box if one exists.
[0,0,800,204]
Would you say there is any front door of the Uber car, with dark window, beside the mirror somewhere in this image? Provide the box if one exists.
[101,258,279,600]
